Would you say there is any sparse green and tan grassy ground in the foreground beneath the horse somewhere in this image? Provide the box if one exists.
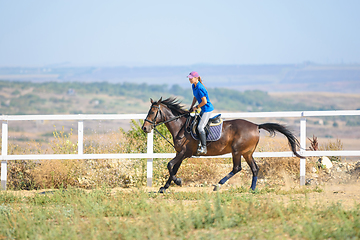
[0,181,360,239]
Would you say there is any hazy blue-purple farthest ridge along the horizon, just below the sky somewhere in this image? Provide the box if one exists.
[0,63,360,93]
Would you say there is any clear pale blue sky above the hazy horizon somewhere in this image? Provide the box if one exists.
[0,0,360,66]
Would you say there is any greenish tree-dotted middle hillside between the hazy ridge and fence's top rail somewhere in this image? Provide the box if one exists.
[0,80,360,115]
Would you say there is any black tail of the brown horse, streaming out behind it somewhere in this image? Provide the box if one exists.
[258,123,304,158]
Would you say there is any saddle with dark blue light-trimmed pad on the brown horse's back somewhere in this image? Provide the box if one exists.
[186,114,223,142]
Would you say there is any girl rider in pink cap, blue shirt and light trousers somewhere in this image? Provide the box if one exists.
[187,72,214,154]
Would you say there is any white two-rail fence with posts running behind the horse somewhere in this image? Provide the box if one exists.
[0,110,360,190]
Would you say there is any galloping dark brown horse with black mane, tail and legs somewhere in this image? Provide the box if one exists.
[141,97,303,193]
